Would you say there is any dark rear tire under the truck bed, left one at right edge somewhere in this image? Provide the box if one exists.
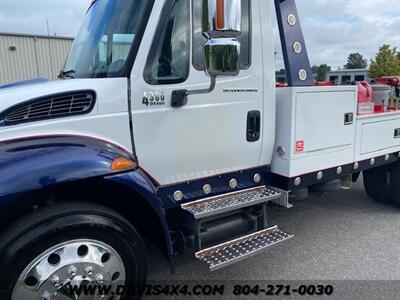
[363,165,392,203]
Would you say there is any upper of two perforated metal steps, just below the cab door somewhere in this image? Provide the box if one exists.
[181,186,282,219]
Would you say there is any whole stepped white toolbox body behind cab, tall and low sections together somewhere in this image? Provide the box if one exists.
[272,86,400,177]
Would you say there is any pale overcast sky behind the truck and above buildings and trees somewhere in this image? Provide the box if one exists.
[0,0,400,68]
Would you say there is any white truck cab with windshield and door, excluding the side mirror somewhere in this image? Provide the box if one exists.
[64,1,275,185]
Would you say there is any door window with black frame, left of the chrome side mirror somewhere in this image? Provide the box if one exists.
[144,0,190,84]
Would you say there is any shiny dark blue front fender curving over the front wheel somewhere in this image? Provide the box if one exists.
[0,136,173,266]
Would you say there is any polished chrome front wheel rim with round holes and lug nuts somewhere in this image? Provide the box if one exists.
[12,240,126,300]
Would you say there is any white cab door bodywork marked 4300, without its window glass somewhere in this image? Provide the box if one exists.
[132,3,263,185]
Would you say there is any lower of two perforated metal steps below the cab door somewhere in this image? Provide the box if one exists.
[195,226,293,271]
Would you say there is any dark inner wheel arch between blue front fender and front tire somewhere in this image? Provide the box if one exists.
[0,173,173,263]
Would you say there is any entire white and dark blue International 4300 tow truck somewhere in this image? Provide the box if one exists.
[0,0,400,300]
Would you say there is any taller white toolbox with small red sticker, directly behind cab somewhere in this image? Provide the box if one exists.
[272,86,358,177]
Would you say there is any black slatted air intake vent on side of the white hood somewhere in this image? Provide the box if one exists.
[1,91,95,125]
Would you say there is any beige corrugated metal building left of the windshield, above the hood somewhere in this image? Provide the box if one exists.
[0,33,73,84]
